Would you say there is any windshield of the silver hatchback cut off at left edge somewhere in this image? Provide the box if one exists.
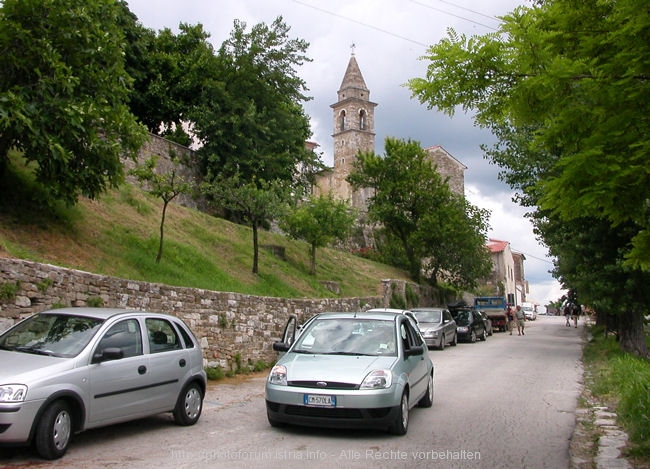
[0,313,103,357]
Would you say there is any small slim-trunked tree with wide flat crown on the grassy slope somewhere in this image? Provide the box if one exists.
[202,175,287,274]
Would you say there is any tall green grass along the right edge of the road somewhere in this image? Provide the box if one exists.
[583,327,650,464]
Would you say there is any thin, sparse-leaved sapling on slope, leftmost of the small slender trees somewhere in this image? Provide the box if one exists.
[131,151,192,264]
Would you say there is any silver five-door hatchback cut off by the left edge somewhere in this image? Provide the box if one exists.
[0,308,206,459]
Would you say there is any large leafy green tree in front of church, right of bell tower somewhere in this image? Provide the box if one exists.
[348,138,492,288]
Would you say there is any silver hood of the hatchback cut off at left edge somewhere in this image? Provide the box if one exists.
[0,350,75,384]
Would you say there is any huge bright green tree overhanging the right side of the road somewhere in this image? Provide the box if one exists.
[408,0,650,356]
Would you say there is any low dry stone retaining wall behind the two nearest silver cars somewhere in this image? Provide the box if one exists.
[0,258,392,370]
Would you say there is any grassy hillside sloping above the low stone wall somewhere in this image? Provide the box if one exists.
[0,155,407,298]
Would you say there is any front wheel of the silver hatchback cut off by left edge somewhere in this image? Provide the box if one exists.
[35,401,72,459]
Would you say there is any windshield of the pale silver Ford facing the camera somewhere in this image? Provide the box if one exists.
[293,318,397,356]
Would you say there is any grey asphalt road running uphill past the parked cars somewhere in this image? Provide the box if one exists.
[0,316,583,469]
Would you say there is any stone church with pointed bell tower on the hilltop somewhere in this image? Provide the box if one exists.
[312,52,467,210]
